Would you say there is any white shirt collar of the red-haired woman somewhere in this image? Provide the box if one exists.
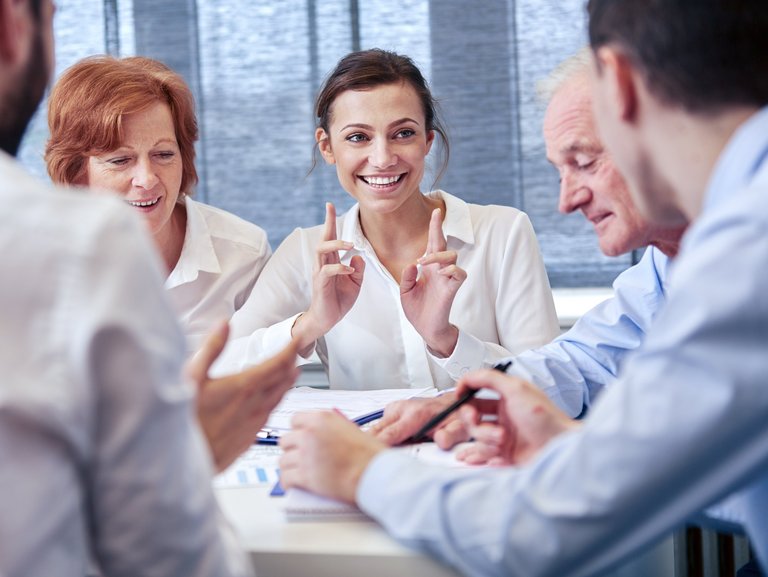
[165,197,221,288]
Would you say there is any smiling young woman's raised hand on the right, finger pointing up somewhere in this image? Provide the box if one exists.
[400,208,467,357]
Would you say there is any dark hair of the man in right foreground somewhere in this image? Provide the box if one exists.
[587,0,768,112]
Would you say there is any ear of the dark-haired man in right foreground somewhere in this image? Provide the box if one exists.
[595,46,640,122]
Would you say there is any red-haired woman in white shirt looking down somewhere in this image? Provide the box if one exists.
[45,56,271,351]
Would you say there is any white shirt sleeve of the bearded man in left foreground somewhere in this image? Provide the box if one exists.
[83,210,252,577]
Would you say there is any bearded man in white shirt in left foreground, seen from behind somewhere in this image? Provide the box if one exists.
[0,0,296,577]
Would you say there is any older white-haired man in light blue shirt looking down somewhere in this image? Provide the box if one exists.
[372,48,685,447]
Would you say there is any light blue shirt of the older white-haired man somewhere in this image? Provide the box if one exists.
[507,247,670,417]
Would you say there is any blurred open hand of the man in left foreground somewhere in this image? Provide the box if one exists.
[186,323,299,471]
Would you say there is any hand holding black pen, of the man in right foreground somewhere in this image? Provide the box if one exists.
[456,369,580,465]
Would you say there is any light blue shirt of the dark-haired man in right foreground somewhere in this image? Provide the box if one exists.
[357,108,768,577]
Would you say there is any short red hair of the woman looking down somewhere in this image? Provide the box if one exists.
[45,56,198,194]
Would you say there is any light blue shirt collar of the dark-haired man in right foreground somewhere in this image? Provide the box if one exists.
[704,106,768,210]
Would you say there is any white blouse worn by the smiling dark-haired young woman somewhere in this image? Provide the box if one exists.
[215,191,558,389]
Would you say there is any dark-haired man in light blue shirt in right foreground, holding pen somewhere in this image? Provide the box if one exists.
[281,0,768,576]
